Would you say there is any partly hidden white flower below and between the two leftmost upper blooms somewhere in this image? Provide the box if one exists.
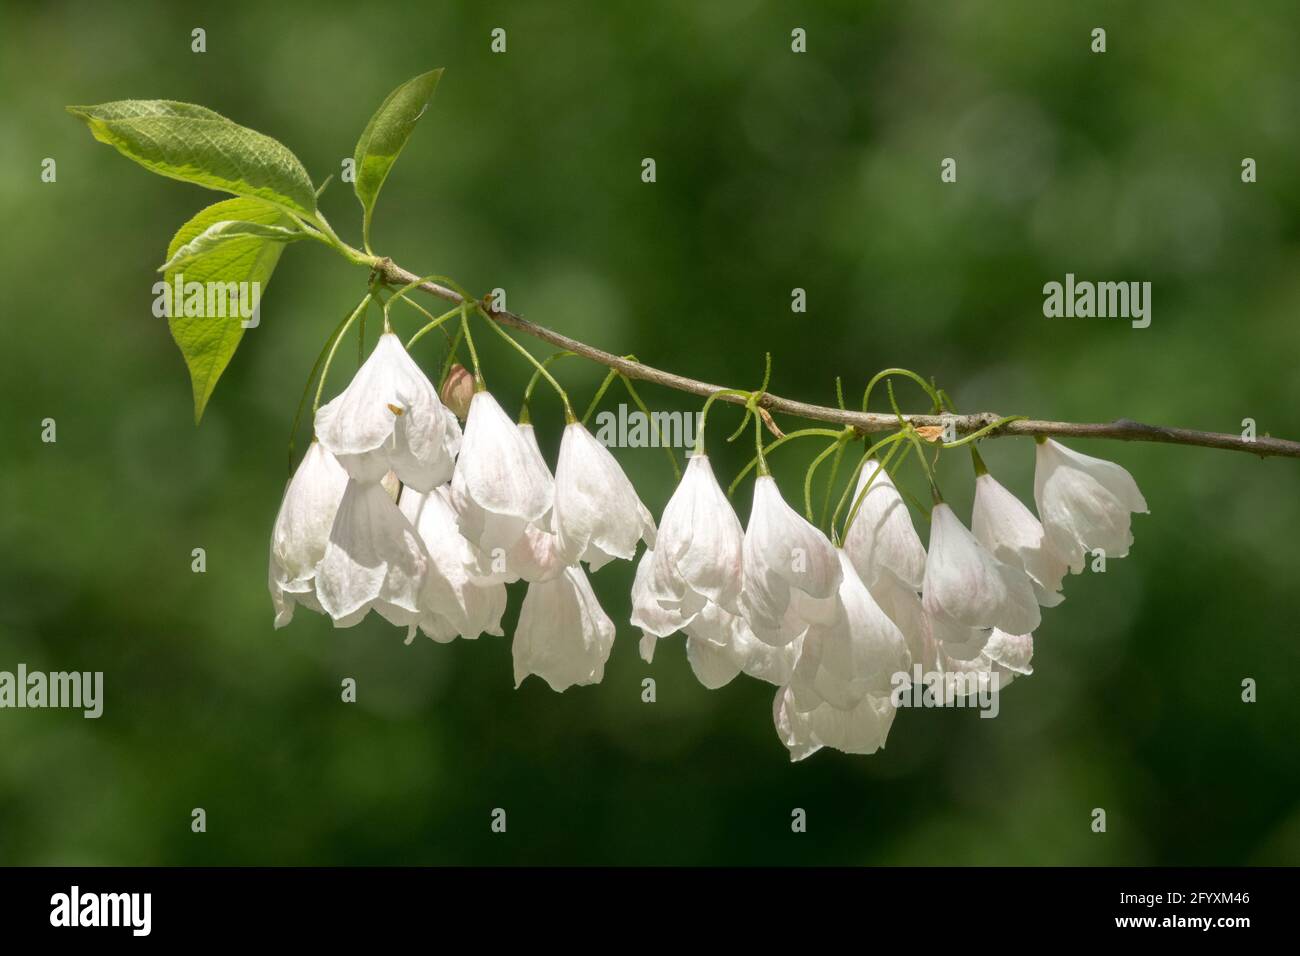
[398,488,506,644]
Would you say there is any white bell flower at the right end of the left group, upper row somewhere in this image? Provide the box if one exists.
[554,421,655,571]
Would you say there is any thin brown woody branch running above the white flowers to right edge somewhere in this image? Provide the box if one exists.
[374,259,1300,458]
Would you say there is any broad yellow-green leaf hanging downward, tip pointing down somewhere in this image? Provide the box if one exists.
[164,199,293,424]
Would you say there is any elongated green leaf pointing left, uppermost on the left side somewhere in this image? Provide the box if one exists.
[68,100,316,219]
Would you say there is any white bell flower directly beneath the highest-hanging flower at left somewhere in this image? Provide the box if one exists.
[316,479,429,627]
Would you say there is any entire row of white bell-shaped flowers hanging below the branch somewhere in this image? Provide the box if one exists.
[269,333,1147,760]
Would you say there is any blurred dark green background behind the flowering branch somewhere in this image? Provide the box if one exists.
[0,0,1300,864]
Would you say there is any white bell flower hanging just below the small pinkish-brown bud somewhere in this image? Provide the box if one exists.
[451,392,554,567]
